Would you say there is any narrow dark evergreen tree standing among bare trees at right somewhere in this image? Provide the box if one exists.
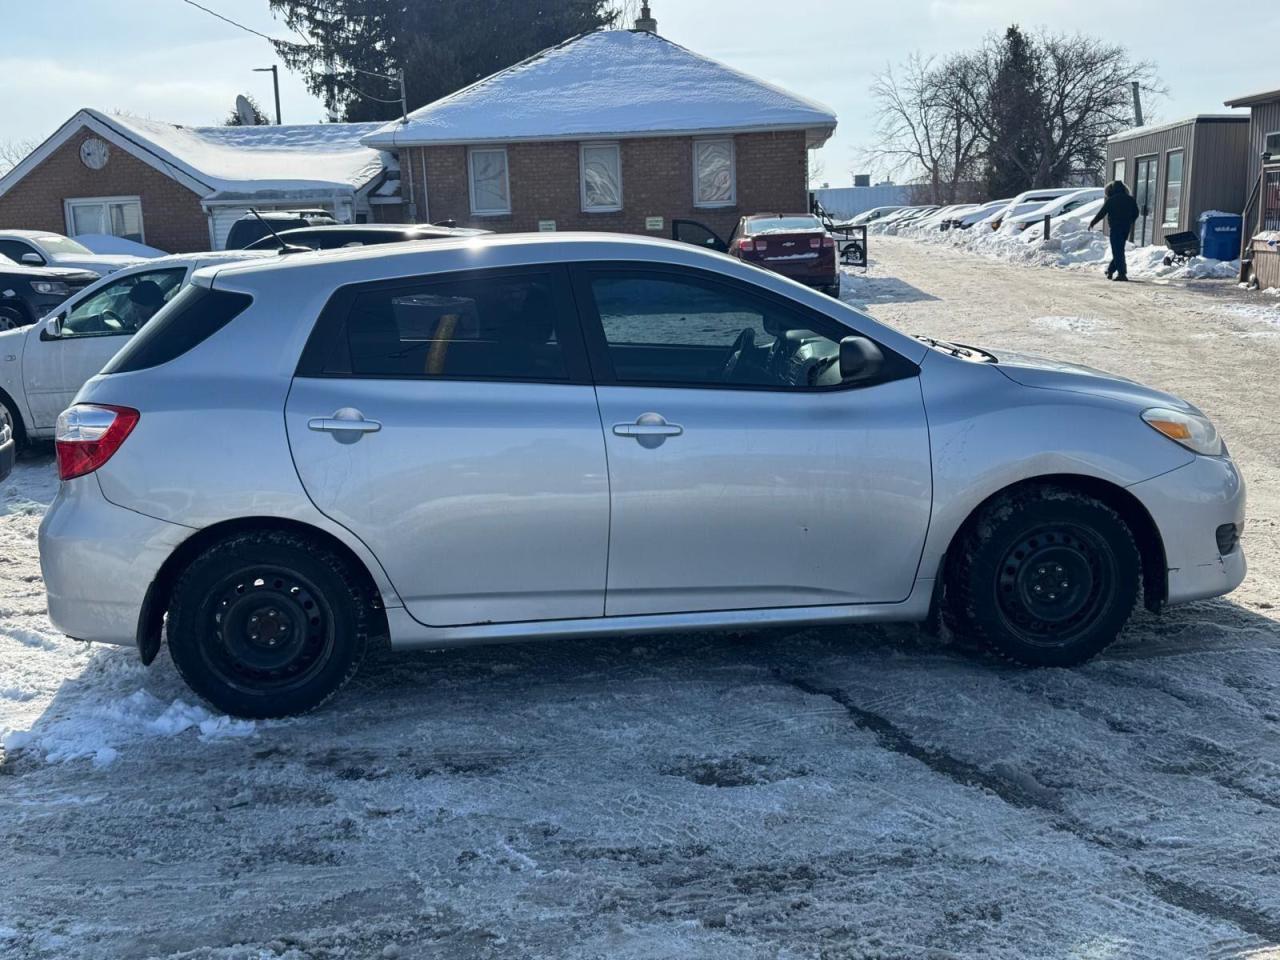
[987,26,1046,197]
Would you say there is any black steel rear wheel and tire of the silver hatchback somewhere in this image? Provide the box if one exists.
[166,530,370,717]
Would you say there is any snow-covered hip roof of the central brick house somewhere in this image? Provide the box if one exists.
[365,31,836,148]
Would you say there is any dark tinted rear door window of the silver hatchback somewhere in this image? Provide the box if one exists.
[320,273,572,380]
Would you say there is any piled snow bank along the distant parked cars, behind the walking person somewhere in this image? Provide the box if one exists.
[870,213,1240,280]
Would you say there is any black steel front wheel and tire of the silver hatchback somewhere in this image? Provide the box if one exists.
[943,486,1142,667]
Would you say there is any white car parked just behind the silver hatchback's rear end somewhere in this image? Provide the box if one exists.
[0,250,267,445]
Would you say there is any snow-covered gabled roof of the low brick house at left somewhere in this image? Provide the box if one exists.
[0,108,393,200]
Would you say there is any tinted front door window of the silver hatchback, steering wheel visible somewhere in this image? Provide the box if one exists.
[590,271,854,389]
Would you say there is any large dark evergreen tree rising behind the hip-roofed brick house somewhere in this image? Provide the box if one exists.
[269,0,614,120]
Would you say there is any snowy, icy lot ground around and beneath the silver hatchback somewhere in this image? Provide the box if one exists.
[0,237,1280,960]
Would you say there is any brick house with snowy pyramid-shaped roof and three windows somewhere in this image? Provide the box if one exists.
[364,17,836,236]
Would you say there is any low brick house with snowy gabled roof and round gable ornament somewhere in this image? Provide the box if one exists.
[0,109,401,253]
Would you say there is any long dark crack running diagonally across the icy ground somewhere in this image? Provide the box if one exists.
[773,668,1280,943]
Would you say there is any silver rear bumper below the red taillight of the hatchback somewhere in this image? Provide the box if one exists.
[40,474,195,645]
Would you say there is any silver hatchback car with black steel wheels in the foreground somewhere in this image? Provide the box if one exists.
[40,234,1244,717]
